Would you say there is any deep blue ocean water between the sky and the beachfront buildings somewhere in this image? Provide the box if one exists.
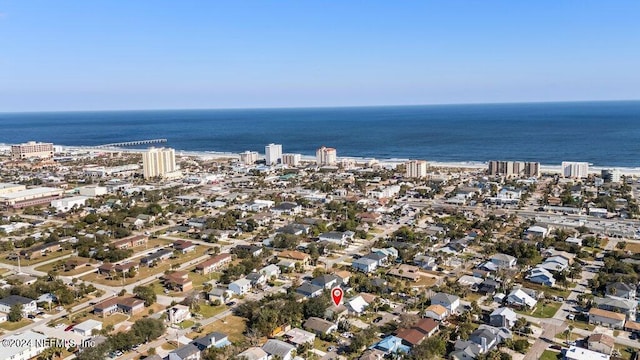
[0,101,640,167]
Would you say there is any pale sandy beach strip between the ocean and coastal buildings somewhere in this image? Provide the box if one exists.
[0,144,640,176]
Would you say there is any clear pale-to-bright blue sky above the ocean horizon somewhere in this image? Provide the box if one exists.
[0,0,640,112]
